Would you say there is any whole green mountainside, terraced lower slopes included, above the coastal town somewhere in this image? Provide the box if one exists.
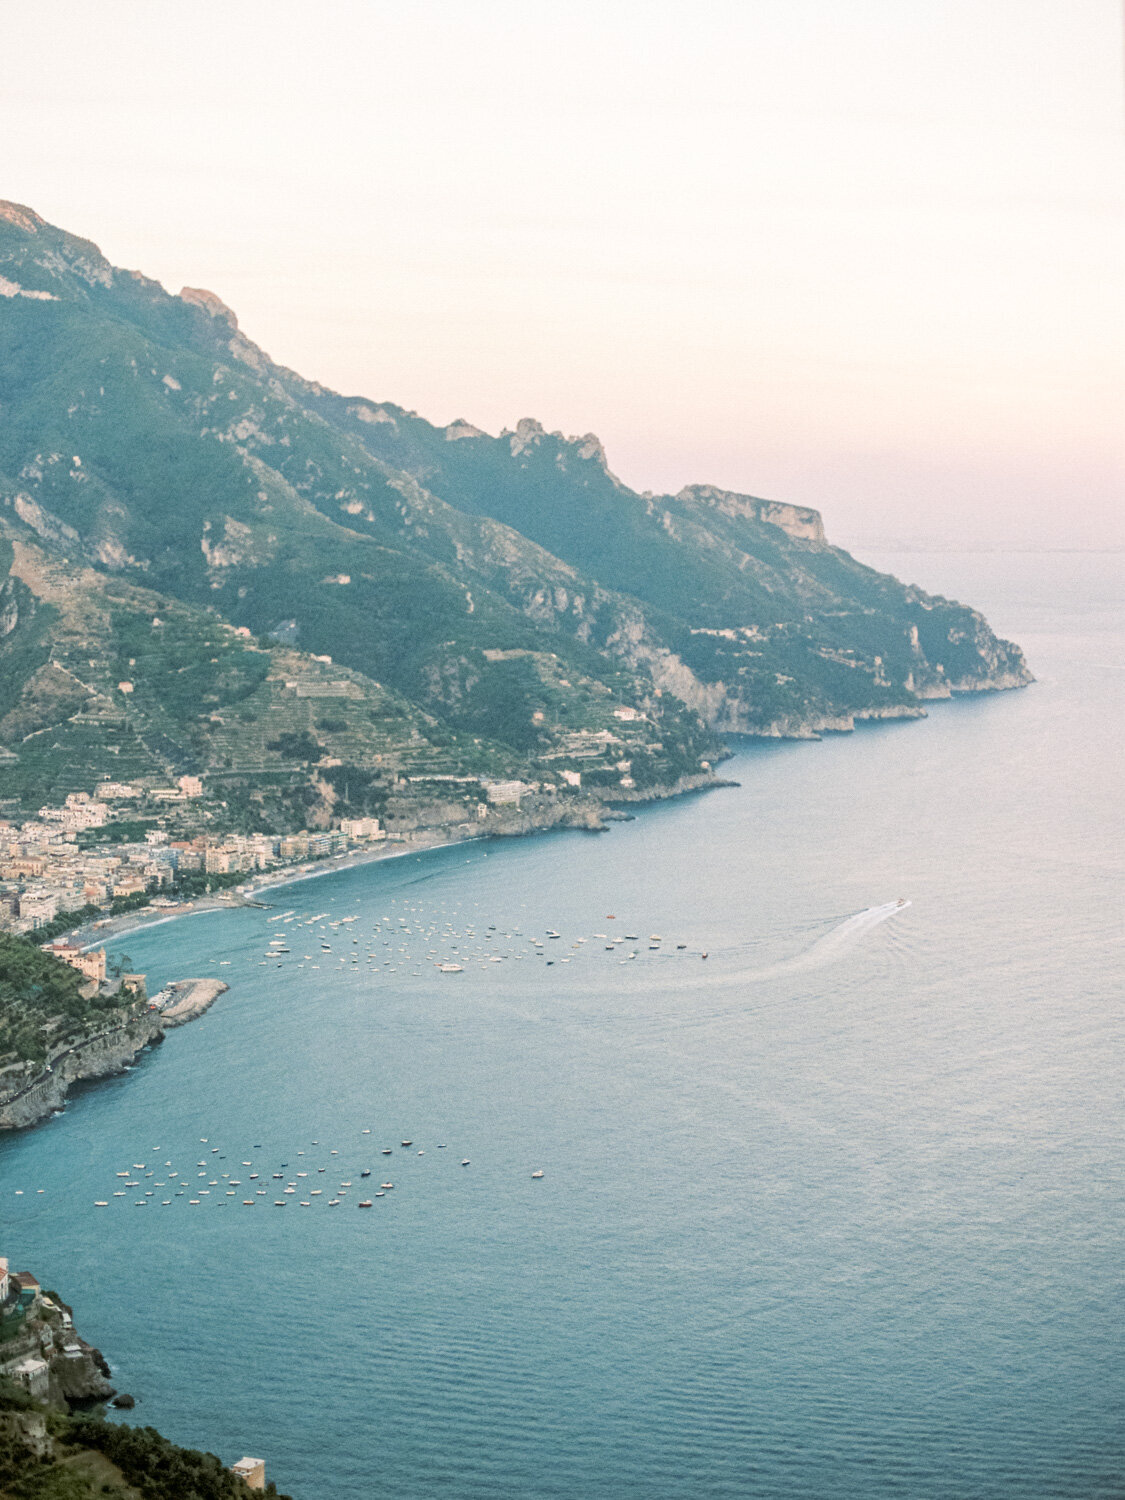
[0,206,1026,821]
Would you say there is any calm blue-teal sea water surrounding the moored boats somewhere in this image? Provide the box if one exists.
[0,555,1125,1500]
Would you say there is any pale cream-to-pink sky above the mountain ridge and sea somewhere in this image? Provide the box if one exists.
[0,0,1125,549]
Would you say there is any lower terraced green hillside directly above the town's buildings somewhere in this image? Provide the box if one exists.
[0,534,713,831]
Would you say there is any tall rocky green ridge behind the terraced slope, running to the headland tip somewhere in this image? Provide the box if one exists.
[0,204,1028,774]
